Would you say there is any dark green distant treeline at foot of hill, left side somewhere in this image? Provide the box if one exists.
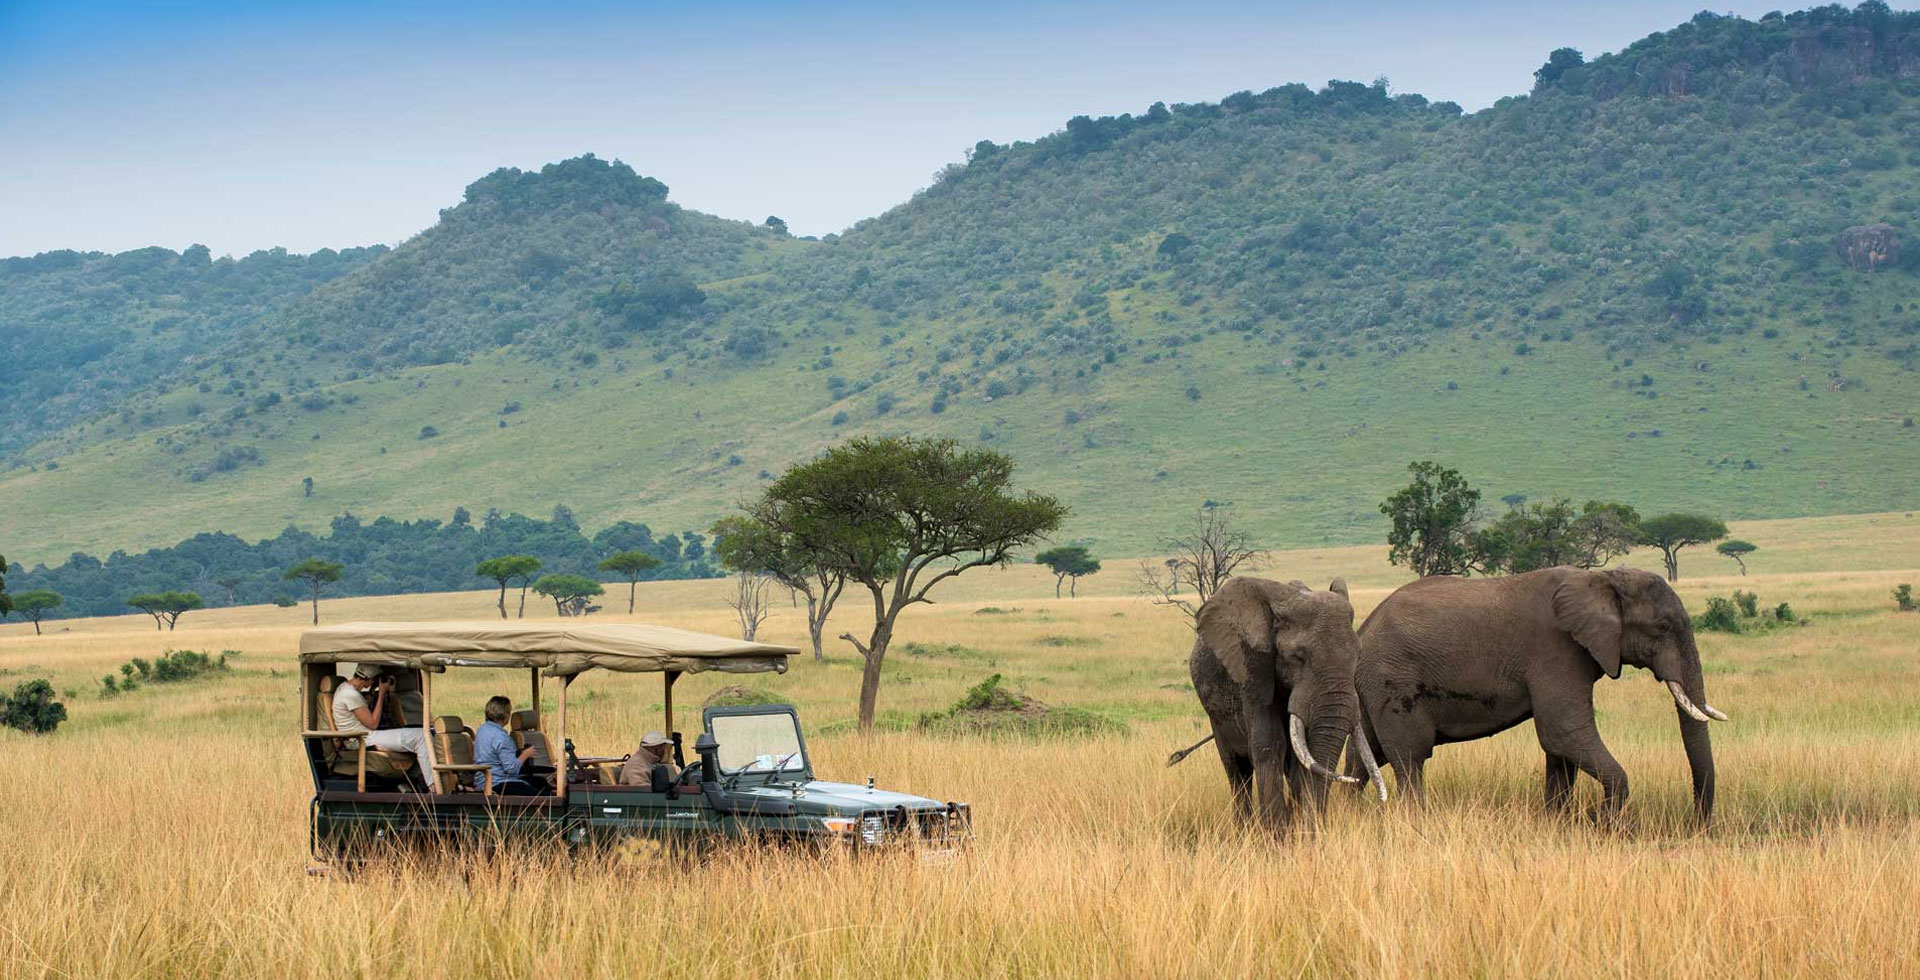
[6,507,720,619]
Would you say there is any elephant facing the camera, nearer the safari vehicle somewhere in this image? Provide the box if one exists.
[1167,578,1386,828]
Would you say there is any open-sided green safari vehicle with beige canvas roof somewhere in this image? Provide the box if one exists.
[300,623,972,861]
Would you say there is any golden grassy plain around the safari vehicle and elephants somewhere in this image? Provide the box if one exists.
[0,513,1920,980]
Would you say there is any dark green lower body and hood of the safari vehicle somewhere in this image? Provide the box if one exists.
[309,705,972,861]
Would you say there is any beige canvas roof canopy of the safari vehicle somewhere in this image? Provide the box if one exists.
[300,621,799,676]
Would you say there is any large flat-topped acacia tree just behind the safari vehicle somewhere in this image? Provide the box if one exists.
[747,436,1068,732]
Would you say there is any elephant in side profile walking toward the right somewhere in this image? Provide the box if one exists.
[1350,567,1726,821]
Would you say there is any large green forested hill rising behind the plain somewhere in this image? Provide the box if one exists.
[0,4,1920,557]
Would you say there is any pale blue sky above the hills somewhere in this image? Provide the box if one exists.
[0,0,1776,256]
